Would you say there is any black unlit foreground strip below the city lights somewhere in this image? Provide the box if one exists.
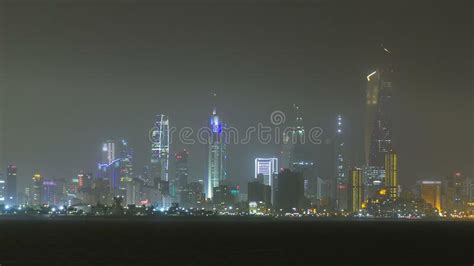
[0,218,474,266]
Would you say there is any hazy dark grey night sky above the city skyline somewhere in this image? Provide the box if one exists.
[0,1,474,191]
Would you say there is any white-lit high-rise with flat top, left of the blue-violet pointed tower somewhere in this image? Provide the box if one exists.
[150,114,170,186]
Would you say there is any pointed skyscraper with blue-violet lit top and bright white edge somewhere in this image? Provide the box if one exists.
[207,108,227,198]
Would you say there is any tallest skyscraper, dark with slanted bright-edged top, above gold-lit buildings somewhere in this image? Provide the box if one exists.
[365,47,394,168]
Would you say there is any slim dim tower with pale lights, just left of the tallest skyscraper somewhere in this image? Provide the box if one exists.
[331,115,348,210]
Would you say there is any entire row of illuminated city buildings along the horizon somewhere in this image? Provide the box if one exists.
[0,46,474,219]
